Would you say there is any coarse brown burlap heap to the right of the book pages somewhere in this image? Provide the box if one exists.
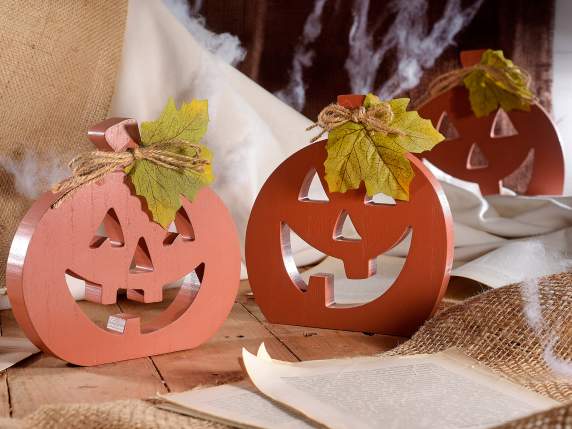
[388,273,572,401]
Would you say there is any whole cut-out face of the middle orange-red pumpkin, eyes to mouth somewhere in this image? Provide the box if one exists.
[281,169,412,308]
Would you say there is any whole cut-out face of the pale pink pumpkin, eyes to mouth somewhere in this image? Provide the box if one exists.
[61,202,205,334]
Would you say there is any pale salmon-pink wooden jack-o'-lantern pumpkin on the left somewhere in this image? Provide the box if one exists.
[7,119,240,365]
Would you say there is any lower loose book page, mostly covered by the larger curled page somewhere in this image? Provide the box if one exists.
[159,383,322,429]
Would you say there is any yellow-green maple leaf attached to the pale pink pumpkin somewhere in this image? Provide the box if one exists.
[125,98,213,228]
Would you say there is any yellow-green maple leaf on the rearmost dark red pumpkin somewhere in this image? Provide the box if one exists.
[463,49,534,117]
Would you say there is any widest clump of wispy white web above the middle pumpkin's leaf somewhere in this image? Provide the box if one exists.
[345,0,483,99]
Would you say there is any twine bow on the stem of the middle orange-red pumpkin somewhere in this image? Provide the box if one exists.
[306,102,404,143]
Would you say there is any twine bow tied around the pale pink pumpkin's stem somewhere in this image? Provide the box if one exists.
[52,141,210,208]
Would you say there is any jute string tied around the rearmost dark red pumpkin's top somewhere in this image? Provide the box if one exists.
[416,64,538,106]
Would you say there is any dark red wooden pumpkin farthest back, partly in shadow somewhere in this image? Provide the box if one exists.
[419,50,564,195]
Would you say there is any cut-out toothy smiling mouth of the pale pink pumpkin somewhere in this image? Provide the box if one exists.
[65,263,205,334]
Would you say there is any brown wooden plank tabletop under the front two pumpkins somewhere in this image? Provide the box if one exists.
[0,281,404,417]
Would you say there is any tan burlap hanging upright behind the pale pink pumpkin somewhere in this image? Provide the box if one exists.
[0,0,127,286]
